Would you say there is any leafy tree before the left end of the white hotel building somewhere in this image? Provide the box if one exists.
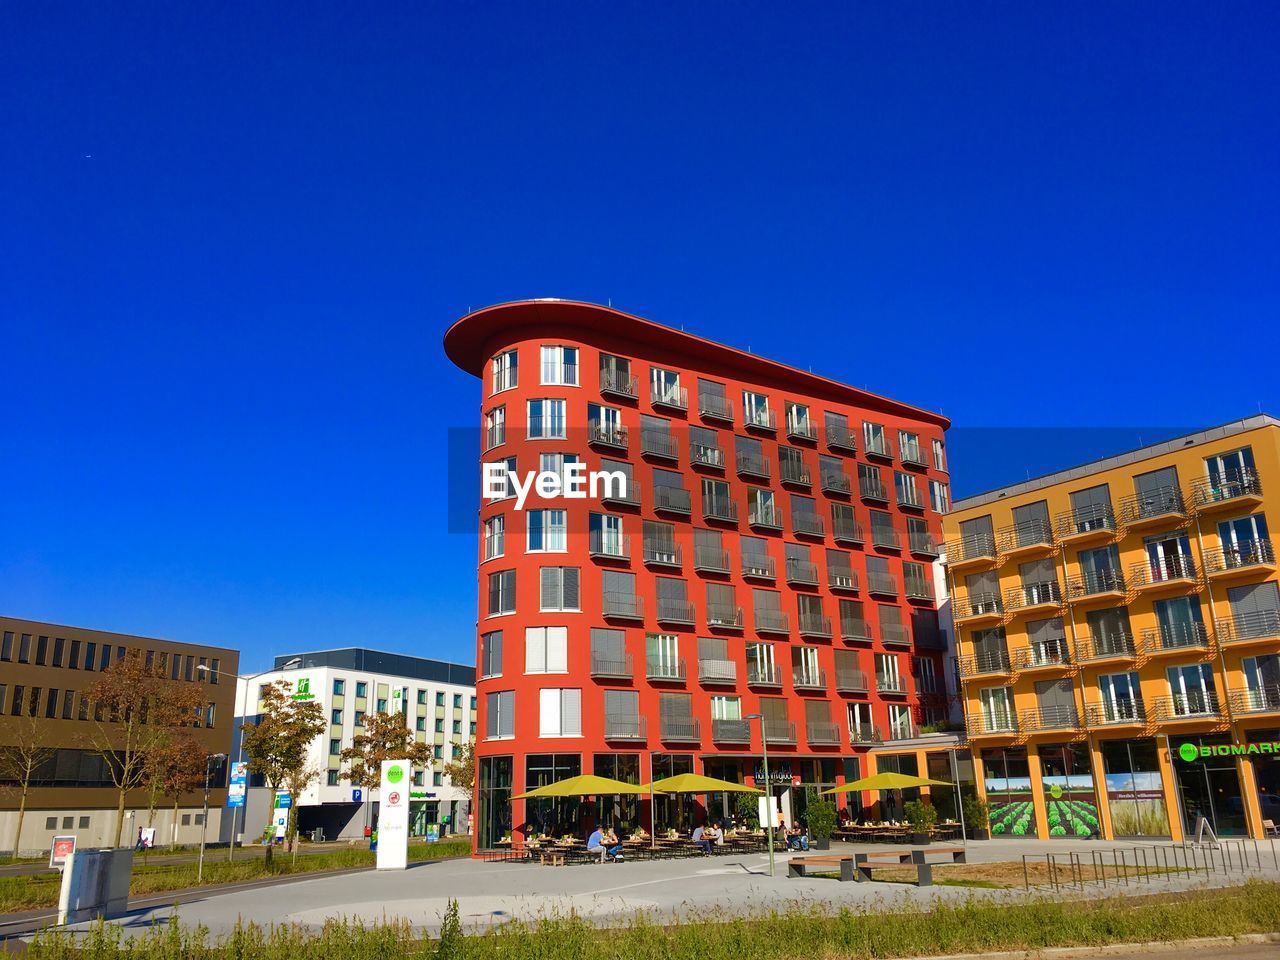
[242,680,328,867]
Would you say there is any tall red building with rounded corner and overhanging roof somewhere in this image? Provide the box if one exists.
[444,301,948,849]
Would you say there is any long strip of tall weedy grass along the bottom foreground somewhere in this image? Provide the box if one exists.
[20,881,1280,960]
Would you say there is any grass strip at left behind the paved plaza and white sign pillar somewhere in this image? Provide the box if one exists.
[0,840,471,914]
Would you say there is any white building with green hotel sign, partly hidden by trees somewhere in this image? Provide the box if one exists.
[223,648,476,844]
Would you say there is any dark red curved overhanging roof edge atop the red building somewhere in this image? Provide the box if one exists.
[444,297,951,430]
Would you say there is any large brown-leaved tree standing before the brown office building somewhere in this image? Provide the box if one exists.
[84,650,205,846]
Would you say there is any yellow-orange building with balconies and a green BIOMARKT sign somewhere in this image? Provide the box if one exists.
[945,416,1280,840]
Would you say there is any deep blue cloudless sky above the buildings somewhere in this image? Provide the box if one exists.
[0,3,1280,666]
